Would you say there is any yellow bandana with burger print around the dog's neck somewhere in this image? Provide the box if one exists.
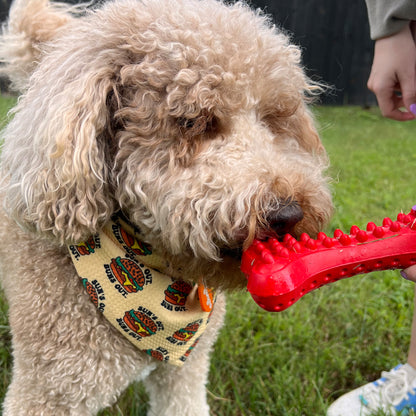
[68,216,215,366]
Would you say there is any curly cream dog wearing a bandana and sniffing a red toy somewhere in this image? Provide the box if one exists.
[0,0,332,416]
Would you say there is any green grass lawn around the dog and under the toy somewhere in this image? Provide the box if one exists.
[0,101,416,416]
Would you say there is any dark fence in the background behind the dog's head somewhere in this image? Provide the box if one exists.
[0,0,375,106]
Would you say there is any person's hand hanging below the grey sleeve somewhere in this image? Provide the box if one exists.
[367,24,416,121]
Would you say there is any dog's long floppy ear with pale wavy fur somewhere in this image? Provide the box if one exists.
[1,63,115,244]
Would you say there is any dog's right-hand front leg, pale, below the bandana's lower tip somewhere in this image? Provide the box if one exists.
[145,295,225,416]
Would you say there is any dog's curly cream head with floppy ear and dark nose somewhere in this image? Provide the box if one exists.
[2,0,332,288]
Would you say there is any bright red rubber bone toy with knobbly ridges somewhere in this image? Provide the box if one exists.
[241,205,416,312]
